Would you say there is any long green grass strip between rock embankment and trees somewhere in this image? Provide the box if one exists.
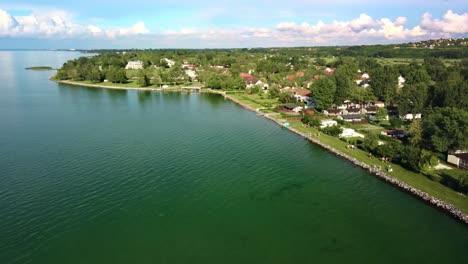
[290,121,468,213]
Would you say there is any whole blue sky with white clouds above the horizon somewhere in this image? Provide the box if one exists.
[0,0,468,48]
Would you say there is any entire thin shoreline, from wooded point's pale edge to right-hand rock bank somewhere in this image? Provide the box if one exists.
[51,79,468,224]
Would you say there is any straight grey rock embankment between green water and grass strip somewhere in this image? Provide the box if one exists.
[219,93,468,224]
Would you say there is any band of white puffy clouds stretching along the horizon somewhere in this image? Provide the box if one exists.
[0,9,468,47]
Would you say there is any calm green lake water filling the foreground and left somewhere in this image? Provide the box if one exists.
[0,51,468,264]
